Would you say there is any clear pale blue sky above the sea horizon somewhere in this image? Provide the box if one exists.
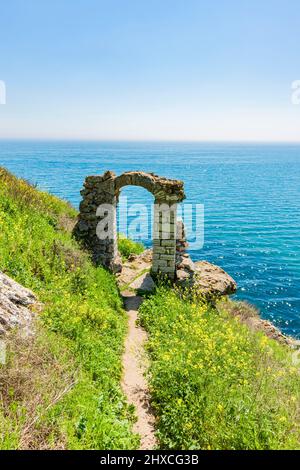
[0,0,300,141]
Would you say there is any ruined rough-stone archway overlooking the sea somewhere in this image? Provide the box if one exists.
[74,171,185,279]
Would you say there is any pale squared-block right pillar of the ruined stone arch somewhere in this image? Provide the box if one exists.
[152,202,177,279]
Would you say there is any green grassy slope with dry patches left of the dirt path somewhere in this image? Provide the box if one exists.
[0,169,138,449]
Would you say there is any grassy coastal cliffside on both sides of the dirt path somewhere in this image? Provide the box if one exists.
[0,169,300,449]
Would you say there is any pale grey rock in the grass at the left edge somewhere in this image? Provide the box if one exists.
[0,271,37,335]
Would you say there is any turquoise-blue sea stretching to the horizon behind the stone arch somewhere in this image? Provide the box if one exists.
[0,141,300,338]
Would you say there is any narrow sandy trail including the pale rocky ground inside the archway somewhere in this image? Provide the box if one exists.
[118,252,157,450]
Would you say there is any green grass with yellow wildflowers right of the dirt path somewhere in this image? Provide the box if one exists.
[140,287,300,450]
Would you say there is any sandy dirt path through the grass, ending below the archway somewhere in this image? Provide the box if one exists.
[122,291,156,450]
